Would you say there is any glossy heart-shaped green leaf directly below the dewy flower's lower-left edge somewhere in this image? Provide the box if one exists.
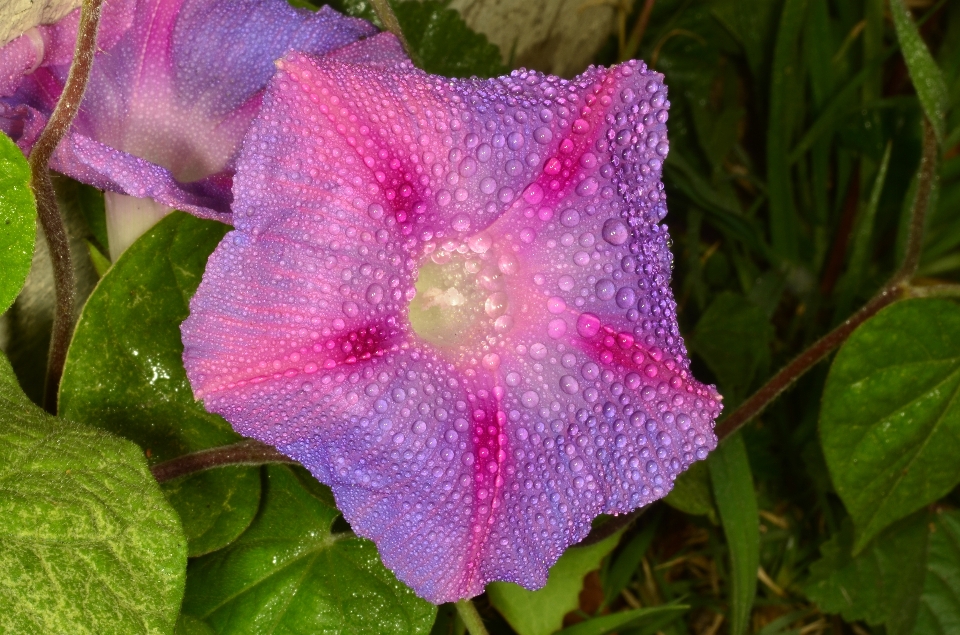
[183,466,436,635]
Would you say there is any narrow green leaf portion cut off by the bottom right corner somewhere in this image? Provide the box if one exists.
[913,511,960,635]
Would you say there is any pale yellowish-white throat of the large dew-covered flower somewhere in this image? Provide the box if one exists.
[408,238,516,350]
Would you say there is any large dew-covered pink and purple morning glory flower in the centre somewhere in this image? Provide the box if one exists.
[182,34,721,603]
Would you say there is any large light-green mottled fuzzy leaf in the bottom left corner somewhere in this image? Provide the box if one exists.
[0,355,187,635]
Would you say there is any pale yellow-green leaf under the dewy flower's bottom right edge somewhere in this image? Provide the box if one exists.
[487,530,623,635]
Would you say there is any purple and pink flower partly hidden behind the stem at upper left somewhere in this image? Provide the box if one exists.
[0,0,376,220]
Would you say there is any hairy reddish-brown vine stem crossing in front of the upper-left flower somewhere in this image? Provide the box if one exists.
[27,0,102,413]
